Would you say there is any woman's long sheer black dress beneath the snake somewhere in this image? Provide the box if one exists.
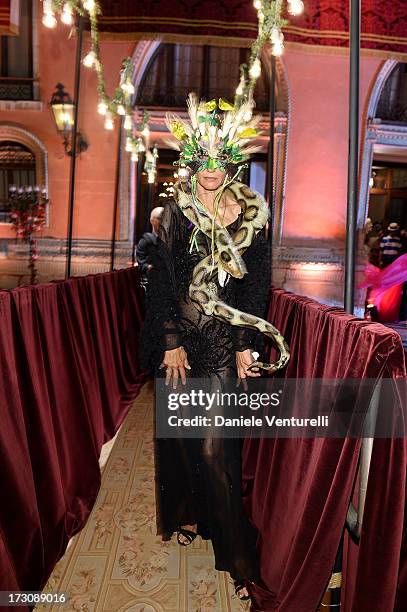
[141,189,270,581]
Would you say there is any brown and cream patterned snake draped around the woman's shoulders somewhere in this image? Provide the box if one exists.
[174,182,290,372]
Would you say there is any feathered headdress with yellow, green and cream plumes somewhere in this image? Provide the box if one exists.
[166,93,261,172]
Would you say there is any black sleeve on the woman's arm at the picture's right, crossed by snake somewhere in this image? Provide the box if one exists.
[232,230,271,351]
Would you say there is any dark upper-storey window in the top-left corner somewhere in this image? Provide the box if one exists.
[0,0,33,100]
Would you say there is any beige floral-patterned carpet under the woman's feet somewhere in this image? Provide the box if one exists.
[36,382,249,612]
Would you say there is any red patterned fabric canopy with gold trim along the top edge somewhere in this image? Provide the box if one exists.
[101,0,407,53]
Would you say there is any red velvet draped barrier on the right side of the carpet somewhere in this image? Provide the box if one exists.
[243,289,406,612]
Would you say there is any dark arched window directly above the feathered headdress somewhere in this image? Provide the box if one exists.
[136,44,280,111]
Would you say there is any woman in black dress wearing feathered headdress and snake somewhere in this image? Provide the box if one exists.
[143,96,290,599]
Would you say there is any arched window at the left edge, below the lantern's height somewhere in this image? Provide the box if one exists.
[0,140,36,223]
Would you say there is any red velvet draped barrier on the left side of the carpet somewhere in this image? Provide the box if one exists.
[0,268,147,590]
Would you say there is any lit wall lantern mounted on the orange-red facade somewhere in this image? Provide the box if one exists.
[50,83,89,155]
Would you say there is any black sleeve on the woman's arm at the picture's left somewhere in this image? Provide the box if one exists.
[141,201,182,368]
